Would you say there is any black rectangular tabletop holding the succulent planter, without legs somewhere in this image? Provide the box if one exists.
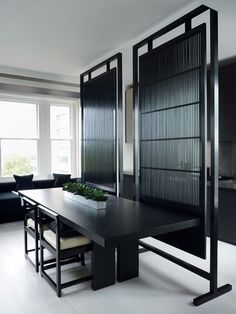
[19,188,200,247]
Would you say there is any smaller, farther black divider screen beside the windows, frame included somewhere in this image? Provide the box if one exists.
[80,53,123,195]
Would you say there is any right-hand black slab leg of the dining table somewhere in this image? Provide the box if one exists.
[117,240,139,281]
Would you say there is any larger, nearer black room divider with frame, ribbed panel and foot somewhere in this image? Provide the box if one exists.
[133,5,232,305]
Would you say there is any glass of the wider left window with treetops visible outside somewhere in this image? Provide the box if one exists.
[0,101,38,177]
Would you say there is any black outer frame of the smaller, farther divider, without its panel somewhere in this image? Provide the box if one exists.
[80,53,123,196]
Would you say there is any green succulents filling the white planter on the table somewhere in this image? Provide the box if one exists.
[63,182,107,202]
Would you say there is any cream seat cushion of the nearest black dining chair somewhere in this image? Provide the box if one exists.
[43,229,91,250]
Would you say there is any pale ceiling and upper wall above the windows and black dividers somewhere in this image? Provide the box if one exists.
[0,0,236,77]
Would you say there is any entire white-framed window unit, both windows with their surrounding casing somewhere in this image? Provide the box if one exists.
[0,96,79,180]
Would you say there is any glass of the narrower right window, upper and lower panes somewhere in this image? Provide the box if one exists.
[50,105,72,173]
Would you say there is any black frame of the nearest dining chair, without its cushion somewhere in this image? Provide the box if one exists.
[37,205,92,297]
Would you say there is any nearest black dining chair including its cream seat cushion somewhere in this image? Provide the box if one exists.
[38,205,92,297]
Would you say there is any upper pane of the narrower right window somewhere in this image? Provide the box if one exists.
[50,106,71,139]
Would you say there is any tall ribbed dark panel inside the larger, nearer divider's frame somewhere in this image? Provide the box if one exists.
[139,25,206,258]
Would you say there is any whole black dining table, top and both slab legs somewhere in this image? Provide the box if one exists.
[19,188,200,290]
